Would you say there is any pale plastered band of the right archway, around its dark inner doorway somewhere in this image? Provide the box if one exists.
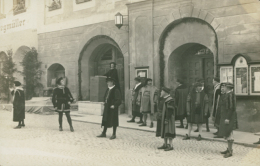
[159,17,218,86]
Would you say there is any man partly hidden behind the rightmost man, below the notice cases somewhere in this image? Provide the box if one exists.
[212,77,221,135]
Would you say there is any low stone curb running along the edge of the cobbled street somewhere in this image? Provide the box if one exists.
[72,119,260,149]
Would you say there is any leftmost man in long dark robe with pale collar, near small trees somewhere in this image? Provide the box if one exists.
[10,81,25,129]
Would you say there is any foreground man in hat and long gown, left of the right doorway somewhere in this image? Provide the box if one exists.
[158,87,176,151]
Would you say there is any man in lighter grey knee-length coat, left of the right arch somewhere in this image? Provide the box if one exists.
[138,78,158,128]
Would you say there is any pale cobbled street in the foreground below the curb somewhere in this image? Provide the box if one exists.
[0,111,260,166]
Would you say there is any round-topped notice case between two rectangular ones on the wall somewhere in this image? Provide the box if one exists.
[234,56,248,95]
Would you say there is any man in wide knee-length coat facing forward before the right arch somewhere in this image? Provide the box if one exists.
[183,83,209,141]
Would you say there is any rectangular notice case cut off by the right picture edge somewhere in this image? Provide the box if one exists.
[250,64,260,95]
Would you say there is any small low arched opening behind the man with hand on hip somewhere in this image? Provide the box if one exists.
[47,63,65,87]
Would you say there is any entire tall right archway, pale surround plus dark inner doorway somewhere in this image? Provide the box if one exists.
[159,17,218,89]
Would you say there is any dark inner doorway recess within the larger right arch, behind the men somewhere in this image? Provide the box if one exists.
[168,43,214,91]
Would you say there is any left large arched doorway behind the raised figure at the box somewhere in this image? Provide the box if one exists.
[78,35,125,101]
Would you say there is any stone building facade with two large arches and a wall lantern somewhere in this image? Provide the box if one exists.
[0,0,260,132]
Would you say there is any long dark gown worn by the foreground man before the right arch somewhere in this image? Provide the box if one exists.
[161,96,176,138]
